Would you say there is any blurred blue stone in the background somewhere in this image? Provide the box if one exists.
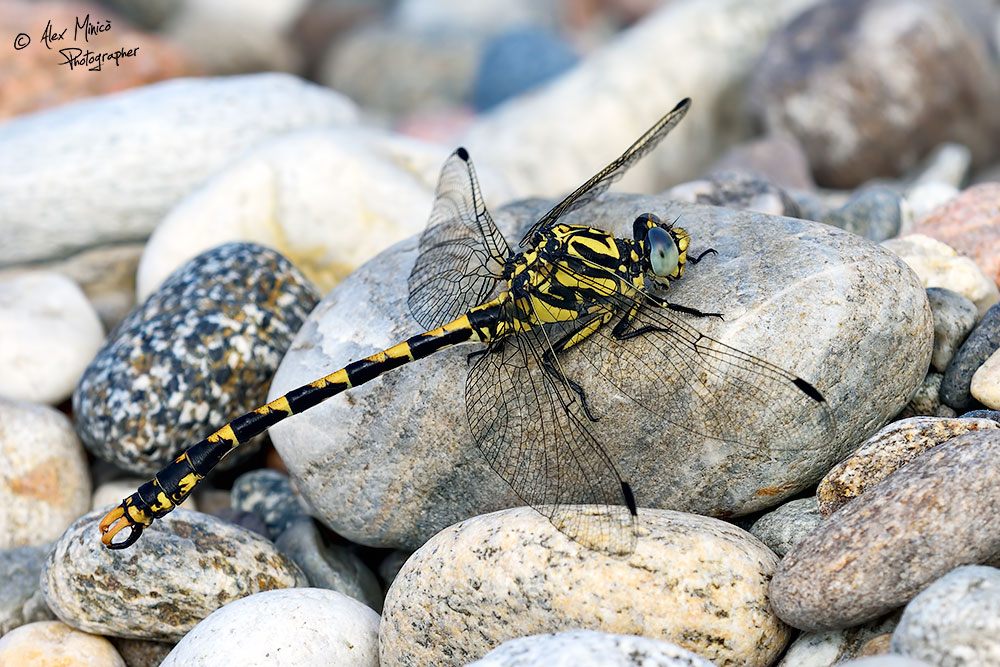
[471,25,578,111]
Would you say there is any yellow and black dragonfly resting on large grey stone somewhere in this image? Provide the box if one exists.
[99,98,833,555]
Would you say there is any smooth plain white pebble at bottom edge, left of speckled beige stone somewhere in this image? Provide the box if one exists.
[160,588,385,667]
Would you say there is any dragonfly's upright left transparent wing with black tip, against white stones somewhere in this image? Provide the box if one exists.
[408,148,511,329]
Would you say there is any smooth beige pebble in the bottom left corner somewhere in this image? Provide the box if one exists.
[0,621,126,667]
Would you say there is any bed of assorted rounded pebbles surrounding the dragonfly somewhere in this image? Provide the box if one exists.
[0,0,1000,667]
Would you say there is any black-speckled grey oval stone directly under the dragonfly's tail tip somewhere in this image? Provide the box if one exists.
[42,506,306,641]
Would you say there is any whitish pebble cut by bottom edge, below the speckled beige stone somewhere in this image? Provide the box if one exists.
[468,630,715,667]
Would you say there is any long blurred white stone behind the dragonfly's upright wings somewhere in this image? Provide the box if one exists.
[464,0,814,197]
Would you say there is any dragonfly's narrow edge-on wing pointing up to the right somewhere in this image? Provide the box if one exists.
[521,97,691,248]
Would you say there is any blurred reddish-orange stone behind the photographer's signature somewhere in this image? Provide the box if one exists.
[0,0,202,119]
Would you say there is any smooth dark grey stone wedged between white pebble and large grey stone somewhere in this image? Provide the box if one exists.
[275,518,383,612]
